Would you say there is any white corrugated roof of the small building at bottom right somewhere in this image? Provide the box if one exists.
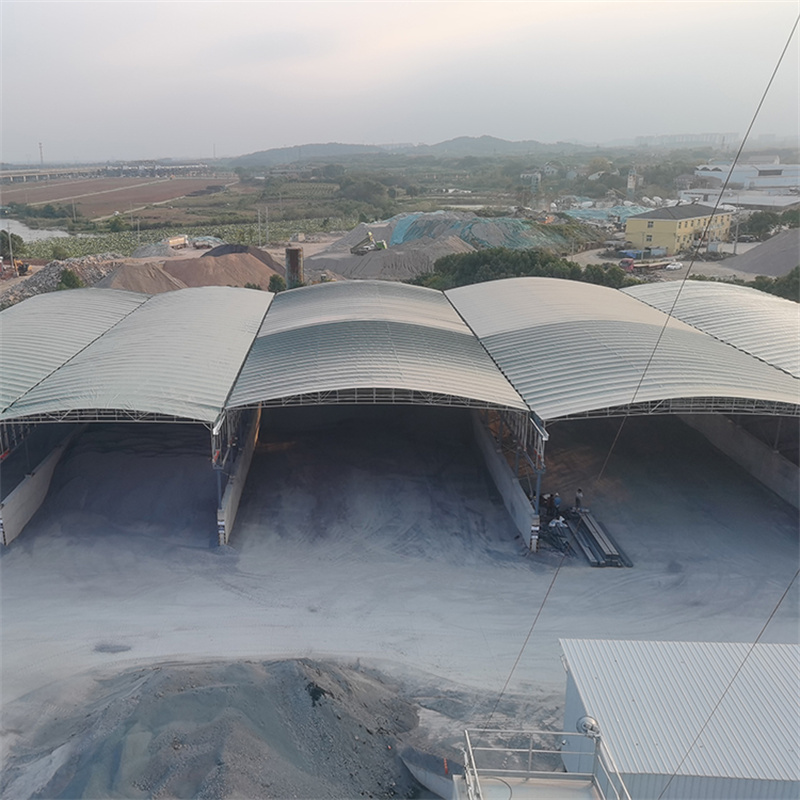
[561,639,800,784]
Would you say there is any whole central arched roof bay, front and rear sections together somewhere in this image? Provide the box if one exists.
[229,281,527,410]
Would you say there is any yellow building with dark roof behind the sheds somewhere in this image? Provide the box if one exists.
[625,203,733,256]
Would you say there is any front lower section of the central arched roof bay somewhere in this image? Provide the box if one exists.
[229,315,527,410]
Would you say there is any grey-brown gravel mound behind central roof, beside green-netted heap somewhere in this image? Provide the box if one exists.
[305,236,475,281]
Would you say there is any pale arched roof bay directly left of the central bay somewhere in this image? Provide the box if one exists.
[4,286,273,423]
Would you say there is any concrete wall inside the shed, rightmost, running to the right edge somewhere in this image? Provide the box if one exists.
[678,414,800,508]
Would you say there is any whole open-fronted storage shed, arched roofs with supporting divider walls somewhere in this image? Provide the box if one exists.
[0,278,800,544]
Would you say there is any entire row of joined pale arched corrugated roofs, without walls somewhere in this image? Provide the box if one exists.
[0,278,800,425]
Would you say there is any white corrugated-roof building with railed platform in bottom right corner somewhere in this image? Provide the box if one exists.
[454,639,800,800]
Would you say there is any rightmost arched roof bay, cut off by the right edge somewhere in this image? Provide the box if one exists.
[622,281,800,378]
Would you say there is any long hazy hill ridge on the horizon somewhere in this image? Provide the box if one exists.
[230,136,592,168]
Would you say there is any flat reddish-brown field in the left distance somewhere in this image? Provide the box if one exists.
[2,176,236,219]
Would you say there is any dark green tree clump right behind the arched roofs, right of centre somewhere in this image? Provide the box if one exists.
[409,247,639,289]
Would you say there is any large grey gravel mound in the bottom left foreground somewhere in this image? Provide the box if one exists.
[2,659,418,798]
